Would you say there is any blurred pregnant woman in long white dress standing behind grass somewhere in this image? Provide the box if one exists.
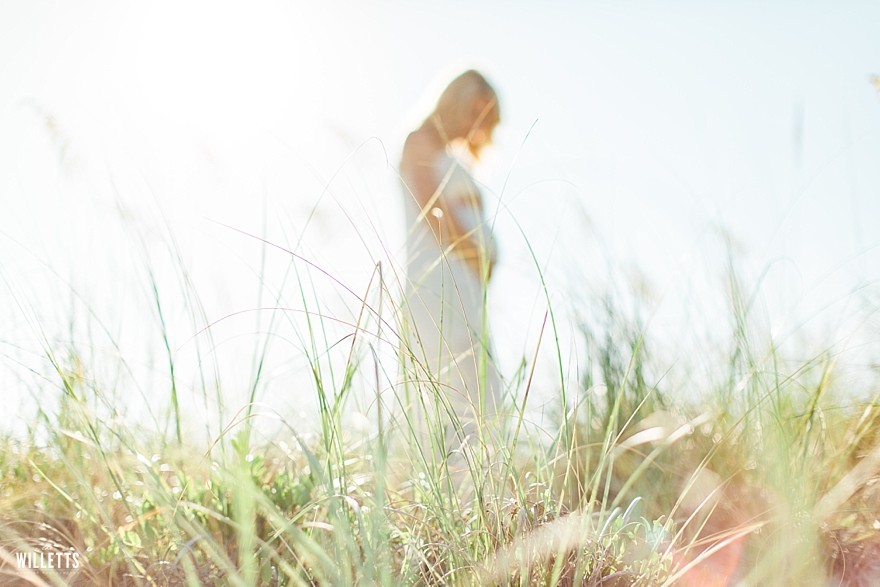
[400,70,501,454]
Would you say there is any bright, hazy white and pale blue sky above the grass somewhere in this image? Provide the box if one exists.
[0,0,880,436]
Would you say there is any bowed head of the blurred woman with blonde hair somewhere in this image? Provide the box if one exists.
[430,69,501,157]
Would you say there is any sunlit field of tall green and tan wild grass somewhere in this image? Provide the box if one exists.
[0,209,880,587]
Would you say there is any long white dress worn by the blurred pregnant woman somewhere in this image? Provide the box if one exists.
[403,152,501,434]
